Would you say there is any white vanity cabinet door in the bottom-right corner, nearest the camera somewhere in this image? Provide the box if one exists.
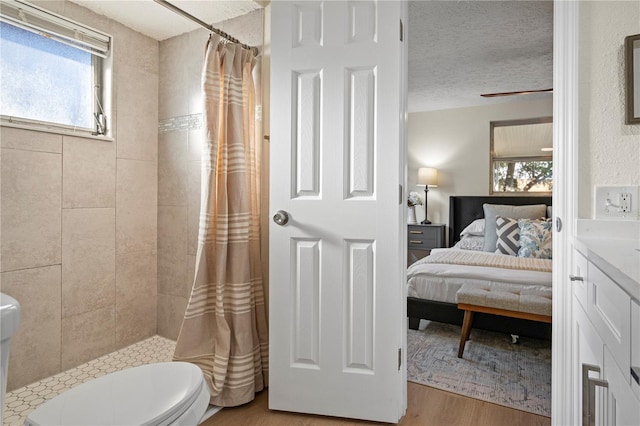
[604,347,640,426]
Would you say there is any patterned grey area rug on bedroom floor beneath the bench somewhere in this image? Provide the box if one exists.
[407,320,551,417]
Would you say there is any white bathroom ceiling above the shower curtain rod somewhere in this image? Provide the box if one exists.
[70,0,262,41]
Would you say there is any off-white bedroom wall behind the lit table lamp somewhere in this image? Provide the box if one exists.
[407,96,553,233]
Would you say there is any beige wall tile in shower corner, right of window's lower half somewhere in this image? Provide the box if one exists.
[117,65,158,161]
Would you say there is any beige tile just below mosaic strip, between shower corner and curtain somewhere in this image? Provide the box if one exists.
[158,132,188,206]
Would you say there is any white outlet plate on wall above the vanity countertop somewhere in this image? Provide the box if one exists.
[594,186,640,220]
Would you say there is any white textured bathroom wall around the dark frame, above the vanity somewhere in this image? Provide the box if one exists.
[578,1,640,219]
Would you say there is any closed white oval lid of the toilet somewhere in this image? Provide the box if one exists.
[25,362,206,426]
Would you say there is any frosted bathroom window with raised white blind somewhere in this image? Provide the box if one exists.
[0,0,111,135]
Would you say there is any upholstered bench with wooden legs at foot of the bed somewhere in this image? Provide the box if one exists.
[456,283,551,358]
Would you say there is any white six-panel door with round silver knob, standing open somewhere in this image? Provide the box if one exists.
[269,1,406,422]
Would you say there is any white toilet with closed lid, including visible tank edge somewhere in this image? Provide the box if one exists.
[0,293,211,426]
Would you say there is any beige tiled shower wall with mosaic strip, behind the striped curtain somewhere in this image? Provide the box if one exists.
[158,10,267,339]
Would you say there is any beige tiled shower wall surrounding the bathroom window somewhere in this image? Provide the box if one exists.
[0,1,159,390]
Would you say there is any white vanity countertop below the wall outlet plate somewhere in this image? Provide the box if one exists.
[573,221,640,301]
